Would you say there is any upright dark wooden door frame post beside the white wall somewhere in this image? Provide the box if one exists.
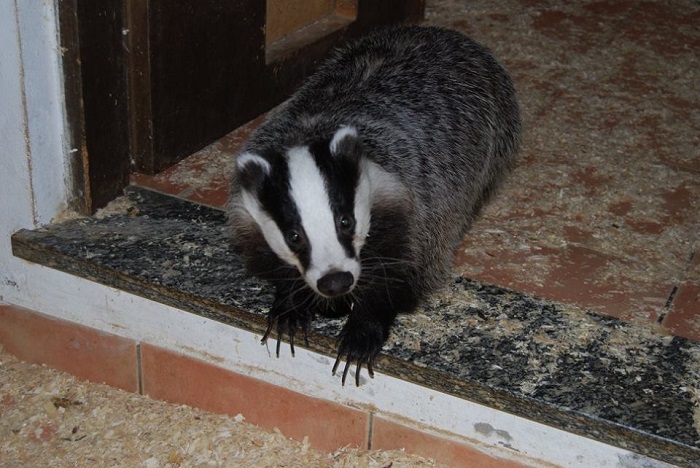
[57,0,130,214]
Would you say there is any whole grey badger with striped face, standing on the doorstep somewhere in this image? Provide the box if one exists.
[228,26,521,385]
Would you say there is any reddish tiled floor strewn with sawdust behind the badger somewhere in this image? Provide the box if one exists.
[133,0,700,340]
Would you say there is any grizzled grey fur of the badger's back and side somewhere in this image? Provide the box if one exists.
[234,26,520,294]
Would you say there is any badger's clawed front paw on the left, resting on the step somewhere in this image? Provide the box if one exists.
[260,286,314,357]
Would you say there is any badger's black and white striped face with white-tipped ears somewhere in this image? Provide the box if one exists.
[237,127,370,297]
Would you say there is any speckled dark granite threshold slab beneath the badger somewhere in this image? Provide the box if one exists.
[12,186,700,466]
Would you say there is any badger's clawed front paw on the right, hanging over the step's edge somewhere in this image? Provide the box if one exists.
[333,319,386,387]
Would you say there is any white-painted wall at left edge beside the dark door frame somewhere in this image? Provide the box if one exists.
[0,0,70,300]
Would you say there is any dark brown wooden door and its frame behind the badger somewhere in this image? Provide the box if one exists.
[59,0,424,212]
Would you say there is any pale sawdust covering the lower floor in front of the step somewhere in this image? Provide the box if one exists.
[0,348,442,468]
